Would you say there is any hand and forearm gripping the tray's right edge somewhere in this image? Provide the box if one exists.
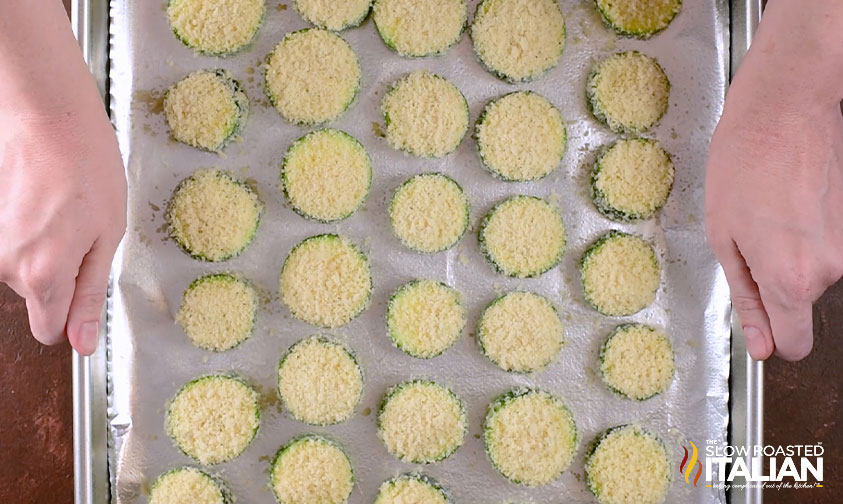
[705,2,843,360]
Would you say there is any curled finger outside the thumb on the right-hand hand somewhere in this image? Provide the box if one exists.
[761,288,814,361]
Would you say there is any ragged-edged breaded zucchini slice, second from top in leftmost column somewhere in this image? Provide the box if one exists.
[164,68,249,152]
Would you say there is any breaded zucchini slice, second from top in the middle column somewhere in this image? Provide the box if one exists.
[381,70,468,157]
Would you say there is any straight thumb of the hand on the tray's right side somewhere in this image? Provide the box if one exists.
[717,236,775,360]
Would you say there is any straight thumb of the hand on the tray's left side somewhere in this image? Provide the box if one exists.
[67,240,114,355]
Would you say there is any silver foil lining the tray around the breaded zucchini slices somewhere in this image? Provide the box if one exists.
[109,0,729,503]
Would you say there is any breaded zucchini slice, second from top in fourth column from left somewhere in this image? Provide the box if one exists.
[475,91,567,182]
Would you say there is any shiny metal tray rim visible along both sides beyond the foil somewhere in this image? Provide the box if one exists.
[71,0,763,504]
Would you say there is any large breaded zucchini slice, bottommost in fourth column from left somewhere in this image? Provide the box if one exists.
[483,388,577,486]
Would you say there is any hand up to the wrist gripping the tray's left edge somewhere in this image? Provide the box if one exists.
[0,106,126,354]
